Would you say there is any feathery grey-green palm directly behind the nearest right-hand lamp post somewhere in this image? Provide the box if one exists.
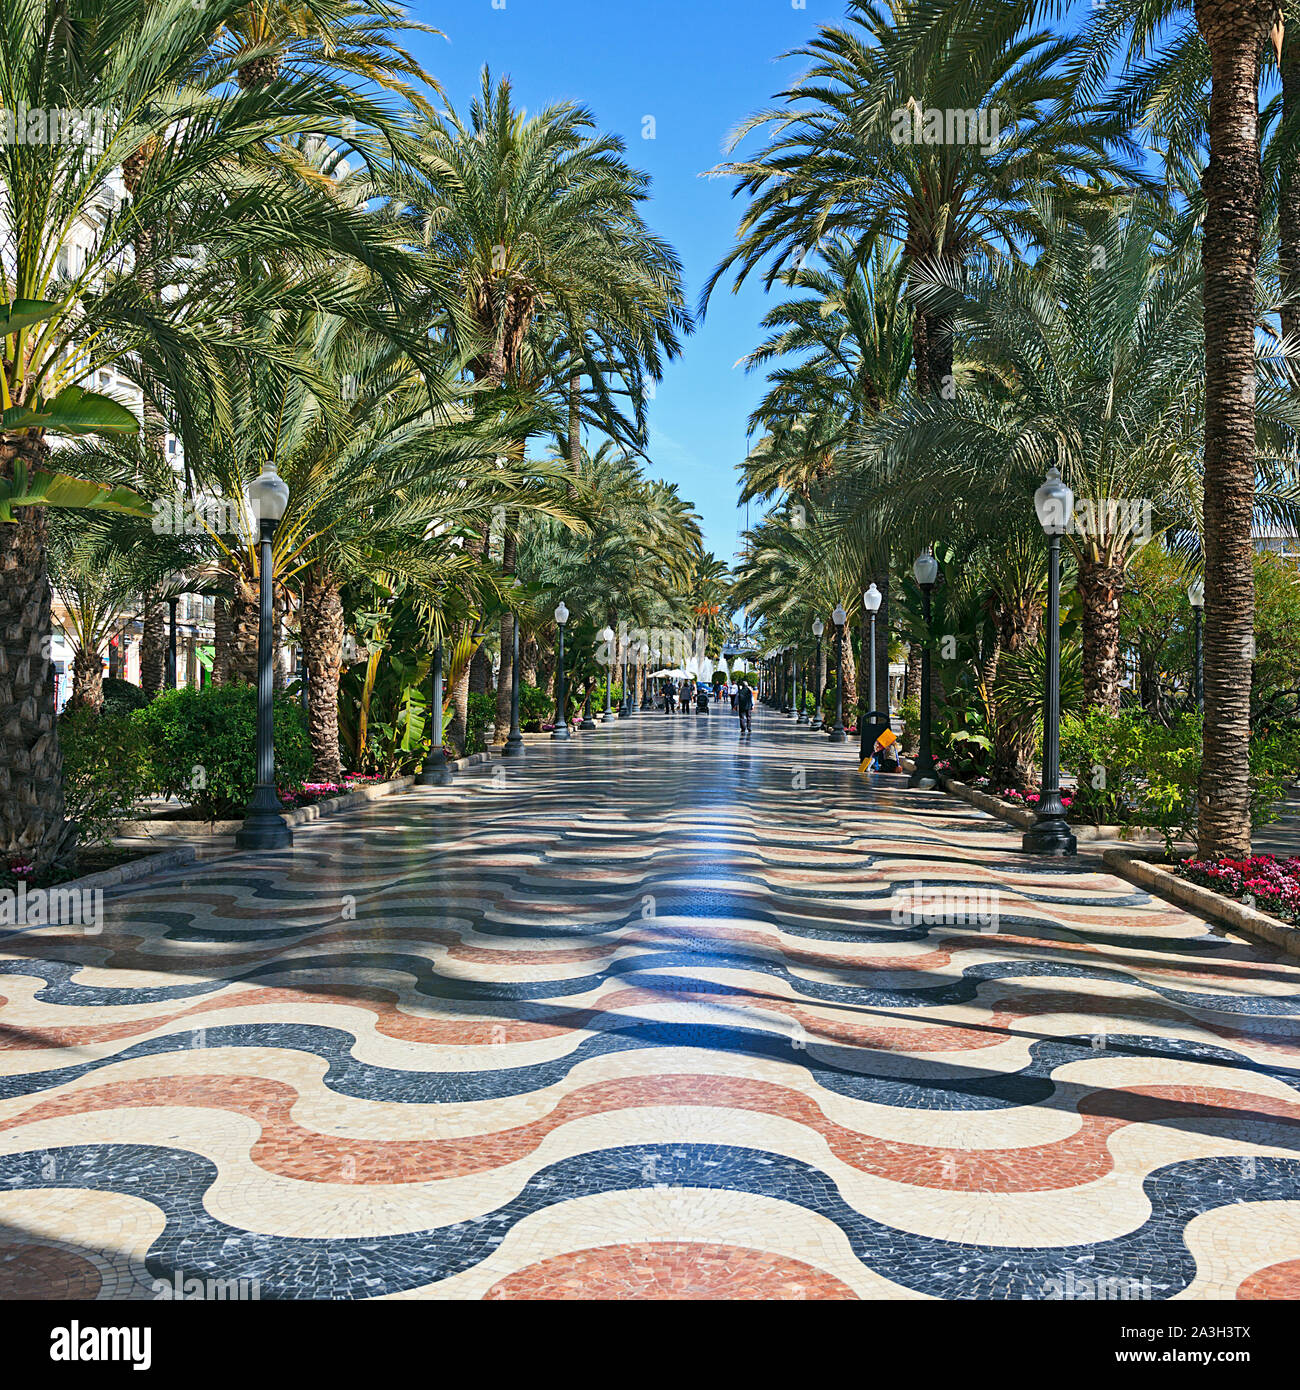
[876,206,1294,710]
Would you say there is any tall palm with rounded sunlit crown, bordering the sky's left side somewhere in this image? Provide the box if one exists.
[393,68,690,750]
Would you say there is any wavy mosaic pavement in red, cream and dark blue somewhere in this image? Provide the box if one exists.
[0,709,1300,1298]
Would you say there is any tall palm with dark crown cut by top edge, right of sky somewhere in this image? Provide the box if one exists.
[704,0,1136,393]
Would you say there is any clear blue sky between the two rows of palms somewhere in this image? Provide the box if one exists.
[409,0,1086,562]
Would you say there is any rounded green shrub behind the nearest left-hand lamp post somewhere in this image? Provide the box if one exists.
[132,684,311,820]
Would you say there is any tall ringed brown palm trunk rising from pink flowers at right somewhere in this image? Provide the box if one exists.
[1196,0,1275,855]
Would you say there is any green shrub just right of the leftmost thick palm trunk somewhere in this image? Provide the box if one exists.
[58,706,154,844]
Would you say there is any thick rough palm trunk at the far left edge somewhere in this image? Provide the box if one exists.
[0,434,75,870]
